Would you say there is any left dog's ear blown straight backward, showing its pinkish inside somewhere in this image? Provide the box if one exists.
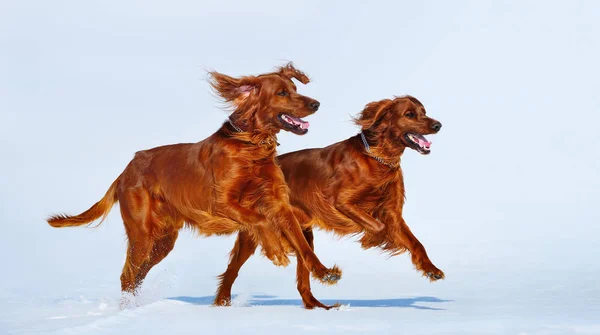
[209,71,259,105]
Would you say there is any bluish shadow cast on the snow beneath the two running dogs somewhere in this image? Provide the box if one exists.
[167,294,452,311]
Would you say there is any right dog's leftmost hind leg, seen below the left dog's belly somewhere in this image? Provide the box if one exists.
[214,231,256,306]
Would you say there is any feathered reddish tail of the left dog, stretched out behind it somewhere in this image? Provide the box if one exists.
[46,176,121,228]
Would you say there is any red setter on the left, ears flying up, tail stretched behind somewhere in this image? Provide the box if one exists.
[48,64,341,294]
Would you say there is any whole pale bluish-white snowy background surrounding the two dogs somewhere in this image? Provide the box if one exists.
[0,0,600,335]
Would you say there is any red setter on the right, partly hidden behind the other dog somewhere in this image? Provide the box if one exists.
[217,96,444,309]
